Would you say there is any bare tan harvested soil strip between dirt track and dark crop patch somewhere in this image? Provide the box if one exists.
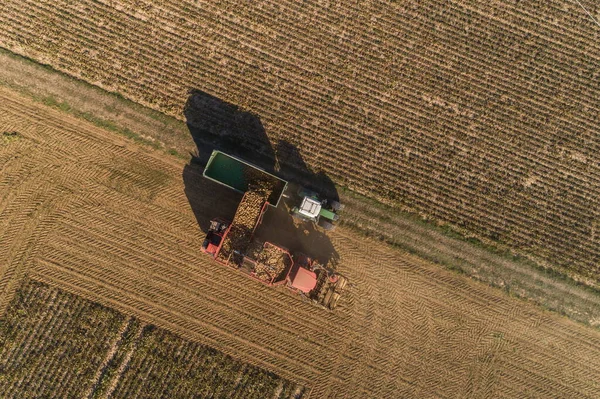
[0,88,600,399]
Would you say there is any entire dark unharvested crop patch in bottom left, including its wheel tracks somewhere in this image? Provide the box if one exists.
[0,280,304,399]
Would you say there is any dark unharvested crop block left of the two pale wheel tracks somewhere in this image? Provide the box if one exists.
[0,282,123,398]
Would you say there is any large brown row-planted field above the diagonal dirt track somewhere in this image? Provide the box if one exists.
[0,0,600,286]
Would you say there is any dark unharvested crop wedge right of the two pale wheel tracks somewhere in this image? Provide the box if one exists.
[113,328,303,399]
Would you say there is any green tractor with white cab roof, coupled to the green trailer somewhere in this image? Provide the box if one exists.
[292,187,344,230]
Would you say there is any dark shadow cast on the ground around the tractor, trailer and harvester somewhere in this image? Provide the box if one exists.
[183,90,339,264]
